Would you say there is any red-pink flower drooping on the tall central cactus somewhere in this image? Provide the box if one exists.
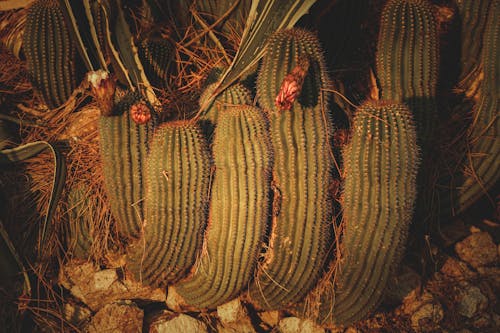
[274,57,309,110]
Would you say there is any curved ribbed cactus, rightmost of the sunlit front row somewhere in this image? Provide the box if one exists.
[310,101,419,326]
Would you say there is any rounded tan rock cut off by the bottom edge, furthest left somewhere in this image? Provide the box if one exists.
[88,301,144,333]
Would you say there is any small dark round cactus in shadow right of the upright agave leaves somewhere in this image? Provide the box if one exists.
[139,38,174,88]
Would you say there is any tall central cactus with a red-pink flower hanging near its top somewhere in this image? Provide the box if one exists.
[249,29,333,309]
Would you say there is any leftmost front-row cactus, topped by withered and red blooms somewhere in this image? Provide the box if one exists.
[99,93,154,237]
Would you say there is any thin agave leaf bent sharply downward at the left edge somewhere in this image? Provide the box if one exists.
[0,141,66,258]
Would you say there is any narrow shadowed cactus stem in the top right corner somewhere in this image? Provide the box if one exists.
[457,0,492,91]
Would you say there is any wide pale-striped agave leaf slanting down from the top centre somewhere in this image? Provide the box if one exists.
[200,0,316,113]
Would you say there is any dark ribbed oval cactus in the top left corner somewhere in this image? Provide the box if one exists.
[23,0,77,108]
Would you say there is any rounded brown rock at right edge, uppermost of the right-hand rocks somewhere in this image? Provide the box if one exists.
[455,232,498,268]
